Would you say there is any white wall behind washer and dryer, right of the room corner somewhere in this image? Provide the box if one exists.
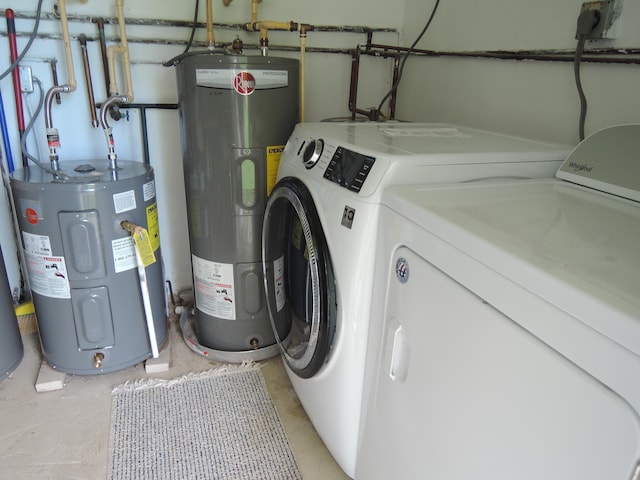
[398,0,640,144]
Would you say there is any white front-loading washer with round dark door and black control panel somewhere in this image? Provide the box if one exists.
[262,123,570,477]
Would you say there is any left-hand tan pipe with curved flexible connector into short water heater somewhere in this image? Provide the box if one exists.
[44,0,76,172]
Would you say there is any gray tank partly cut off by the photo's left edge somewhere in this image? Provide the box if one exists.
[0,249,24,380]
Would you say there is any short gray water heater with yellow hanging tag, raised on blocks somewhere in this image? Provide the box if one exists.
[11,160,167,375]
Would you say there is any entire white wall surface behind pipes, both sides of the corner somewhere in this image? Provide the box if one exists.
[8,0,640,302]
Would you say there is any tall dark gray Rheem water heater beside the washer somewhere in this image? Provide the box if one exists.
[176,52,300,355]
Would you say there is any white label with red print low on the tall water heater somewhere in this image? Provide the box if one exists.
[191,255,236,320]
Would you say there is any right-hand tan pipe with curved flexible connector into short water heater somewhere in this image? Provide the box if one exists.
[100,0,133,171]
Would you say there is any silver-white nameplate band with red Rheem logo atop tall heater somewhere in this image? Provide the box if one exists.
[196,68,289,89]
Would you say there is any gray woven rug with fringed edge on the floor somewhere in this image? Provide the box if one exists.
[109,363,302,480]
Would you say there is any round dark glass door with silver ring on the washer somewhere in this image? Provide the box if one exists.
[262,177,336,378]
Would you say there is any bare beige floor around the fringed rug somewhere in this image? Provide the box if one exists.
[0,321,348,480]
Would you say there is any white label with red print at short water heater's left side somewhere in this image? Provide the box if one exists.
[25,252,71,298]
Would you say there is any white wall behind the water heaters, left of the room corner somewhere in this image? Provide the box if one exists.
[0,0,404,290]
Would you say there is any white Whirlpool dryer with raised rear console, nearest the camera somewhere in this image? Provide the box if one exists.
[356,125,640,480]
